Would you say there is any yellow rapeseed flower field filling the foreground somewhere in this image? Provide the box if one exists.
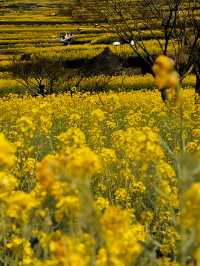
[0,70,200,266]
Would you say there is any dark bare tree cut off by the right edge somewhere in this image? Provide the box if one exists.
[171,0,200,87]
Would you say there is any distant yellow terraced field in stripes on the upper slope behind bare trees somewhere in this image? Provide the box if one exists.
[0,0,200,93]
